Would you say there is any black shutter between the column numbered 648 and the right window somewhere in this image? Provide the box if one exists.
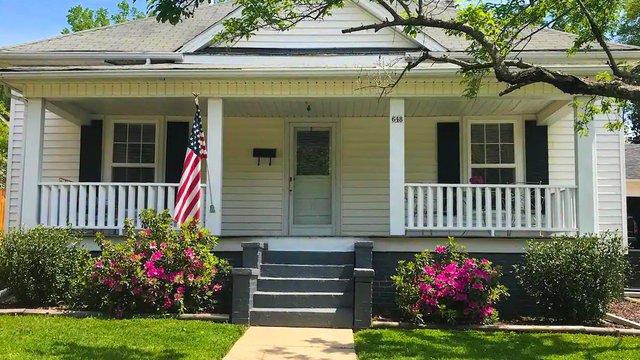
[438,123,460,184]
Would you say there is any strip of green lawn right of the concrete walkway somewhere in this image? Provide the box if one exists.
[355,330,640,360]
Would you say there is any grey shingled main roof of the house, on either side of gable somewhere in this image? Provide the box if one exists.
[0,2,639,54]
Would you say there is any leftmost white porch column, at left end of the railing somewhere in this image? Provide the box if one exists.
[20,98,45,227]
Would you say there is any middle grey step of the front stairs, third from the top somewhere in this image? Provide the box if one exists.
[258,277,353,292]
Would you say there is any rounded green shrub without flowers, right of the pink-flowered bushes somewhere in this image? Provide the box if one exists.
[515,233,628,324]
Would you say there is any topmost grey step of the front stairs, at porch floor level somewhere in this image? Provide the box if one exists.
[262,251,354,265]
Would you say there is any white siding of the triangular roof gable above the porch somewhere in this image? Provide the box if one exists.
[229,3,416,49]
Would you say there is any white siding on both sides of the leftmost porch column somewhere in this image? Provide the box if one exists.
[7,100,80,227]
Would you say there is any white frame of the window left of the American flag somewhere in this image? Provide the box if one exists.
[102,116,166,183]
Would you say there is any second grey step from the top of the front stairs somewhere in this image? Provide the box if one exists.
[260,264,353,279]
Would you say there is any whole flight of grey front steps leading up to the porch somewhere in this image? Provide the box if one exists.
[250,251,354,328]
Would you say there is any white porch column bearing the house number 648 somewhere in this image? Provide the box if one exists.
[389,99,405,236]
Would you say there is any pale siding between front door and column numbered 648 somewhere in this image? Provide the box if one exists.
[341,118,389,236]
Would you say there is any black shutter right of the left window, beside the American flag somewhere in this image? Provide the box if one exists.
[164,121,189,183]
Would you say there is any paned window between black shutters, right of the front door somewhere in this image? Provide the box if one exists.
[470,122,516,184]
